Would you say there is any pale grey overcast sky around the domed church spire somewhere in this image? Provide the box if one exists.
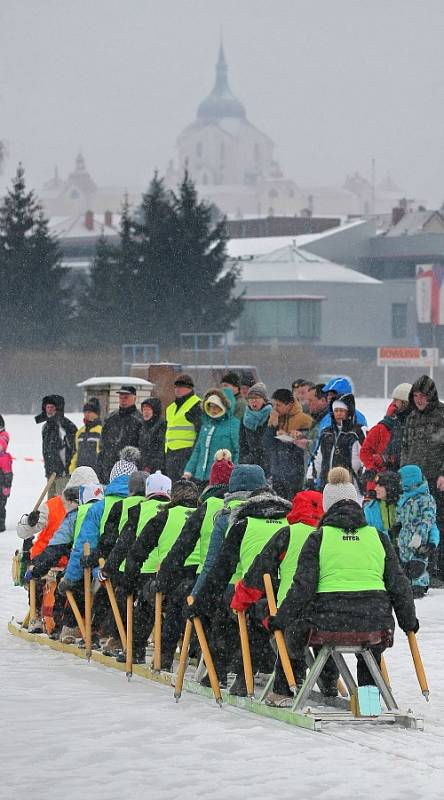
[0,0,444,204]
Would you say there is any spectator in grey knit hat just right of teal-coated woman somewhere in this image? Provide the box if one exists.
[239,383,273,470]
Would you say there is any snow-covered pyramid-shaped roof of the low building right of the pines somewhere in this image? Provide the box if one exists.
[240,244,380,285]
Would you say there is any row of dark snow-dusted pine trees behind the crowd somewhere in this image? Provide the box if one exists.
[0,165,242,348]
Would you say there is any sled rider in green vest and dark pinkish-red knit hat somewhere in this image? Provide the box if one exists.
[146,450,234,671]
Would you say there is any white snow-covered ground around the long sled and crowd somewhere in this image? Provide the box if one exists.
[0,400,444,800]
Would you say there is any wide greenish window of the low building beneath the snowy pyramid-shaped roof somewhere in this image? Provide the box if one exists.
[239,298,321,341]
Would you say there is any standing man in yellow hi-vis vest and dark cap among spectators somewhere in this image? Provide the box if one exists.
[165,373,202,483]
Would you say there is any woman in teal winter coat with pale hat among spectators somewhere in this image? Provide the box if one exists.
[183,388,240,484]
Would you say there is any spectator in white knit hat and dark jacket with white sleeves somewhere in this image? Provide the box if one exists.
[307,394,364,491]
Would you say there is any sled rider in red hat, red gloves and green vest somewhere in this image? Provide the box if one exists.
[231,490,324,706]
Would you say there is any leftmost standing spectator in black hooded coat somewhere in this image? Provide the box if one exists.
[35,394,77,498]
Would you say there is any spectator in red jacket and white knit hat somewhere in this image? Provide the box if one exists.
[359,383,412,493]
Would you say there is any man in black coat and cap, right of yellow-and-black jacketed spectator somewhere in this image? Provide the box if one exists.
[98,386,143,483]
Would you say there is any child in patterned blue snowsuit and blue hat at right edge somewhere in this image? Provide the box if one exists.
[397,464,439,598]
